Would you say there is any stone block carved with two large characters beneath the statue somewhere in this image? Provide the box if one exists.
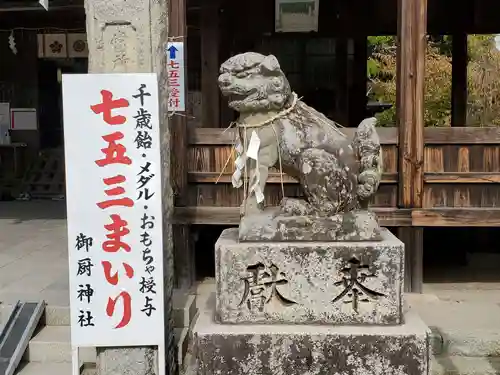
[215,228,404,325]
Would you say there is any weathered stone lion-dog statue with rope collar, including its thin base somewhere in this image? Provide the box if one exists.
[219,52,382,241]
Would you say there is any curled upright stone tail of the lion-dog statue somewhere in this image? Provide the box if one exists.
[352,117,382,207]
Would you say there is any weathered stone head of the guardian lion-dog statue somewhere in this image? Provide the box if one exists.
[219,52,291,113]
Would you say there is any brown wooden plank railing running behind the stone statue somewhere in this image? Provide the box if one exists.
[175,127,500,226]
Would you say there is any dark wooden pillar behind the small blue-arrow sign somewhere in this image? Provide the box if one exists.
[168,0,195,289]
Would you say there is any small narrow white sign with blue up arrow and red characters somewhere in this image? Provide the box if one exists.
[165,42,186,112]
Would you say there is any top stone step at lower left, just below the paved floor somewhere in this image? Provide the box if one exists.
[45,290,196,328]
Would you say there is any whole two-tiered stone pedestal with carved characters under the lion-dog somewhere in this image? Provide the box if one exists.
[194,229,430,375]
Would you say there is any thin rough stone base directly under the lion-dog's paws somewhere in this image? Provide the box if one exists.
[239,207,381,242]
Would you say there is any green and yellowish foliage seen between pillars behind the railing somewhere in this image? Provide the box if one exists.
[367,35,500,126]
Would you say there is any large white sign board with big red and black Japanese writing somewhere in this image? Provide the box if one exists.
[63,74,165,369]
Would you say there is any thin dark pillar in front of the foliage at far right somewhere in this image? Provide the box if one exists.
[451,32,468,126]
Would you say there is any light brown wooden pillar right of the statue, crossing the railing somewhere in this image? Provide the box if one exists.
[396,0,427,293]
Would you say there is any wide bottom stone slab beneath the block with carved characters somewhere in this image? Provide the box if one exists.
[194,312,430,375]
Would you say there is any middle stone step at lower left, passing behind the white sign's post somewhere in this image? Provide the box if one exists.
[23,326,189,363]
